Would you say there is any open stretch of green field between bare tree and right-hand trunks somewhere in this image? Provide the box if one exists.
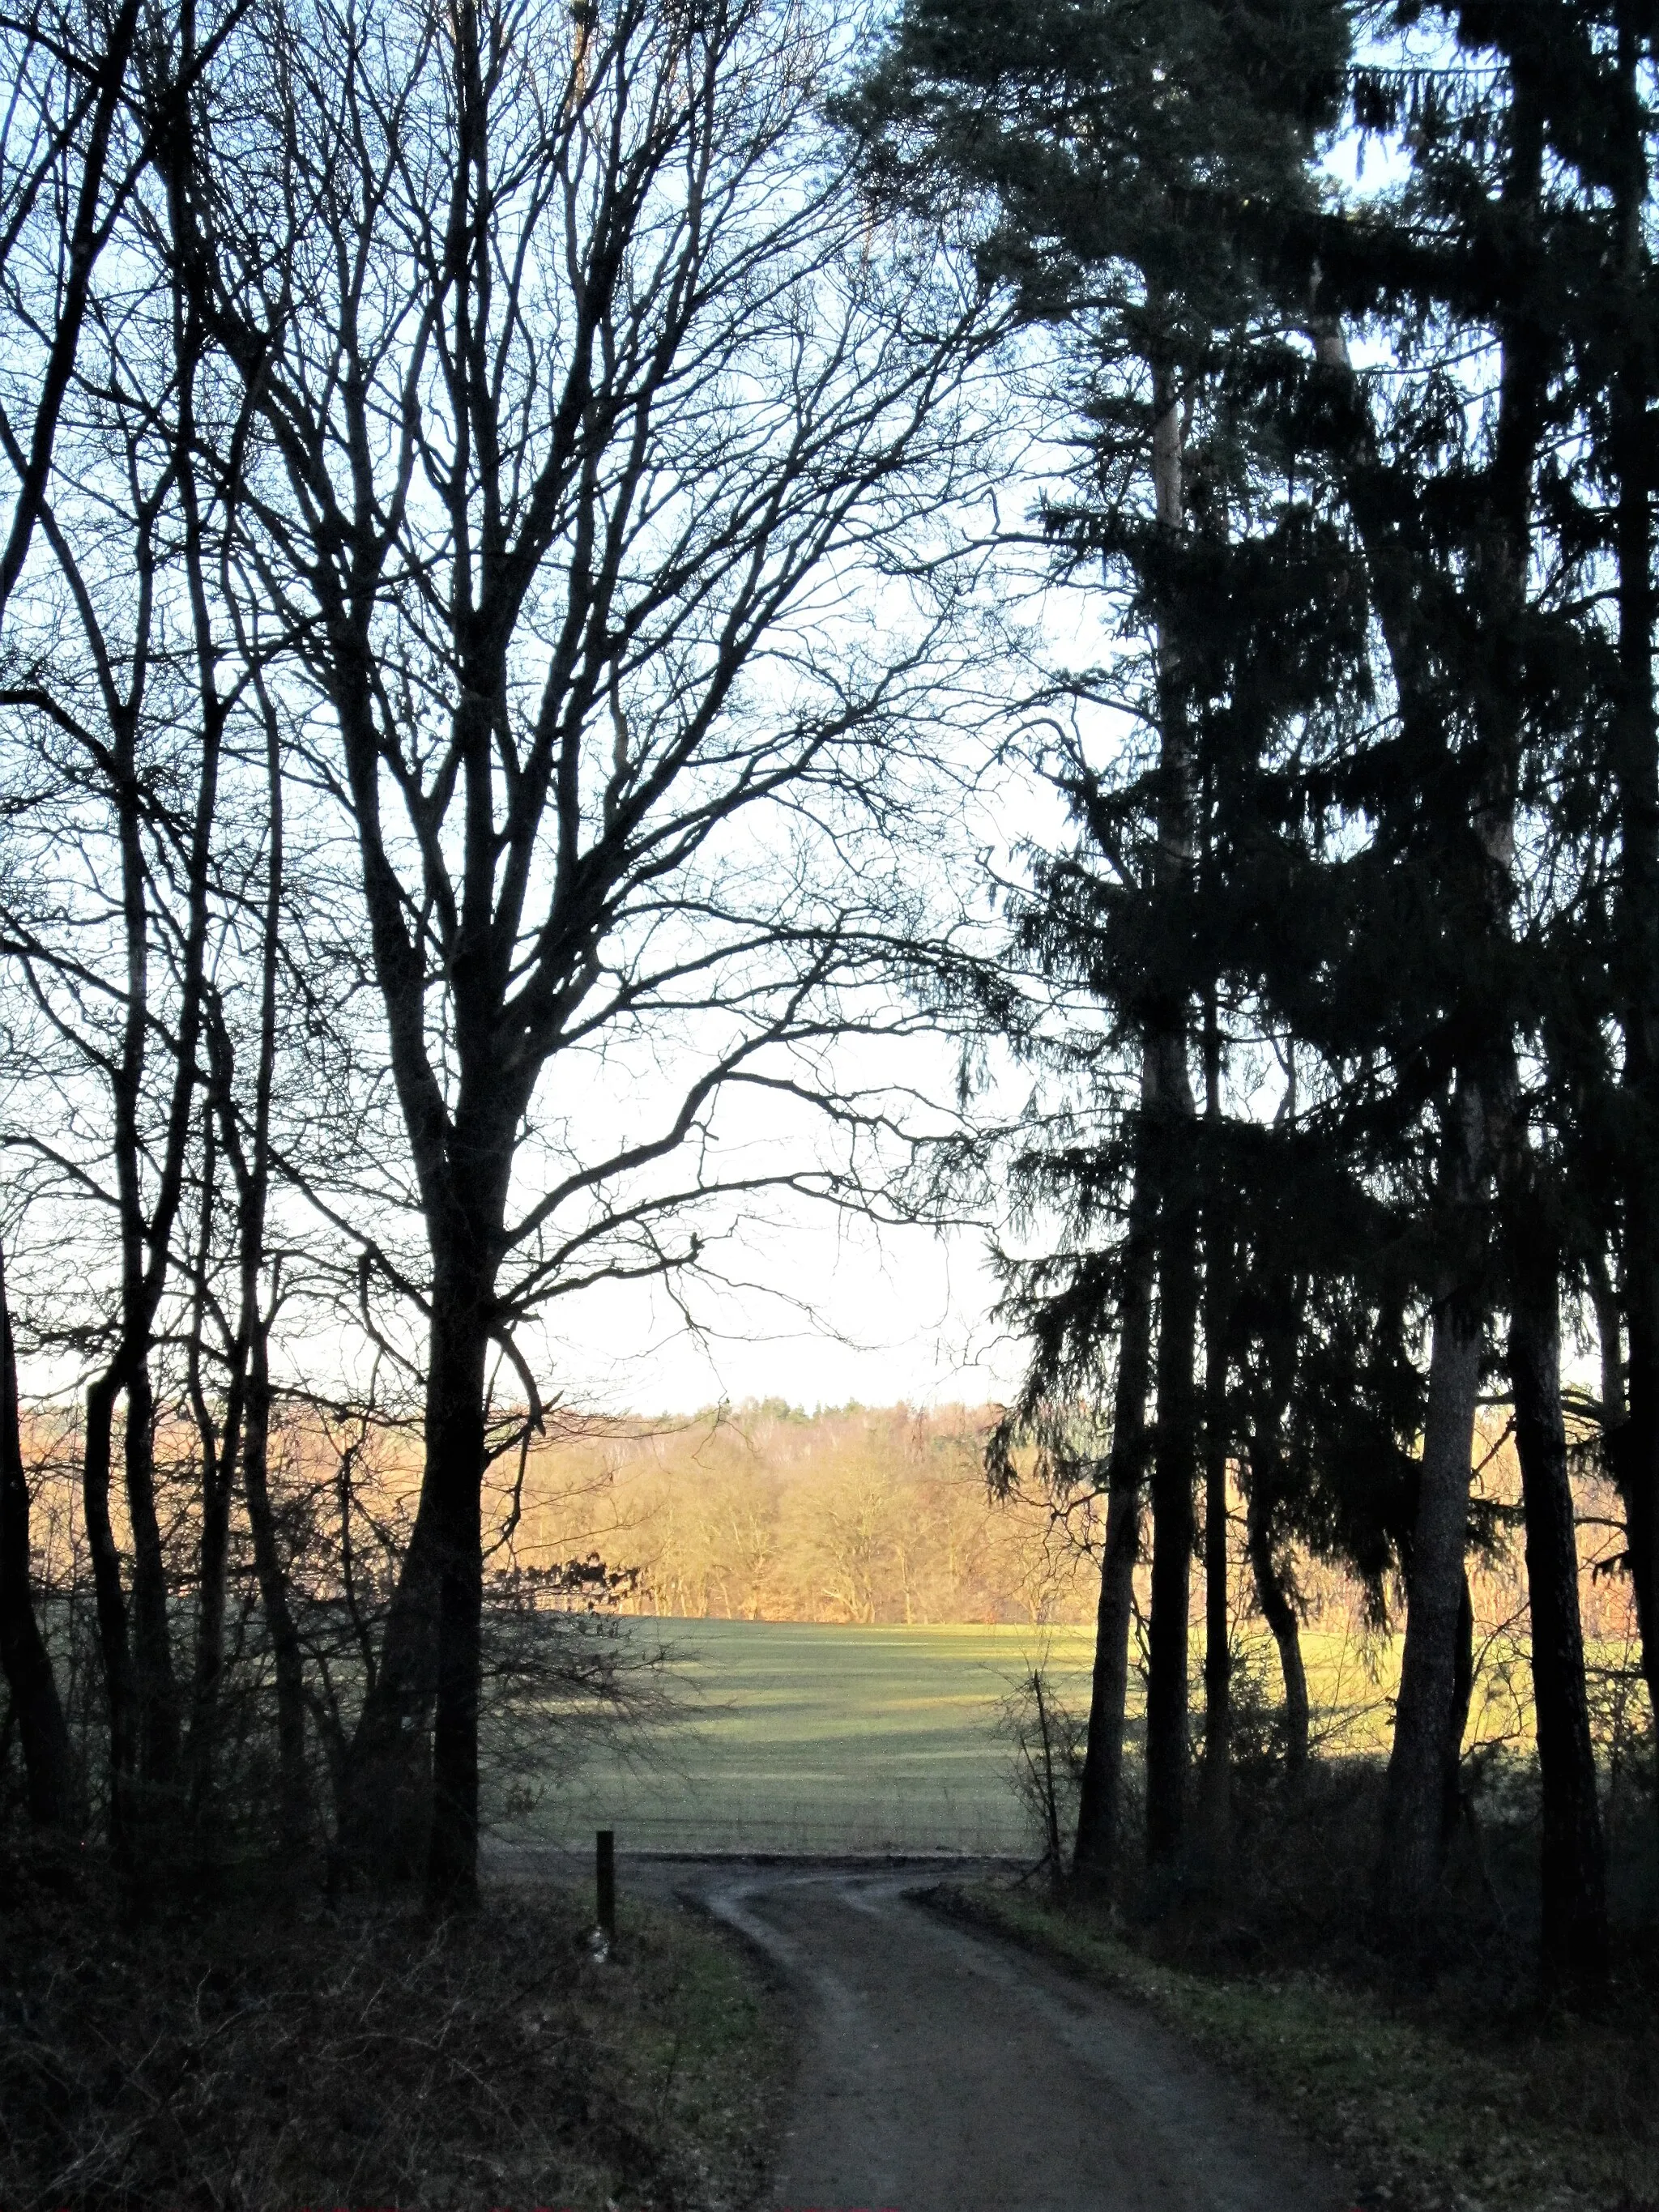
[514,1619,1093,1852]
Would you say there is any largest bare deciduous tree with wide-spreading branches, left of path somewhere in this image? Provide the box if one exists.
[173,0,995,1903]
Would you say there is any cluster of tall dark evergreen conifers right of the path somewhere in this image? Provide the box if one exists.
[856,0,1659,1986]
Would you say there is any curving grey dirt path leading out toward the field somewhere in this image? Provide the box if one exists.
[663,1867,1351,2212]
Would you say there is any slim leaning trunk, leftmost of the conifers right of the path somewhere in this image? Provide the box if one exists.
[1073,1115,1154,1889]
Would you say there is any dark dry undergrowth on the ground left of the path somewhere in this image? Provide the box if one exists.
[0,1858,781,2212]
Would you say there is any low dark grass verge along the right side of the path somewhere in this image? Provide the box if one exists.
[938,1885,1659,2212]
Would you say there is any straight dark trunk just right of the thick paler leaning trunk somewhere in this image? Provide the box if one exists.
[1508,1254,1608,1993]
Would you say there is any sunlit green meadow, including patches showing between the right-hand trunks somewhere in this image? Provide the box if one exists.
[509,1619,1639,1854]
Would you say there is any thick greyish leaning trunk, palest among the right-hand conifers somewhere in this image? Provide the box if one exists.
[1378,1077,1482,1937]
